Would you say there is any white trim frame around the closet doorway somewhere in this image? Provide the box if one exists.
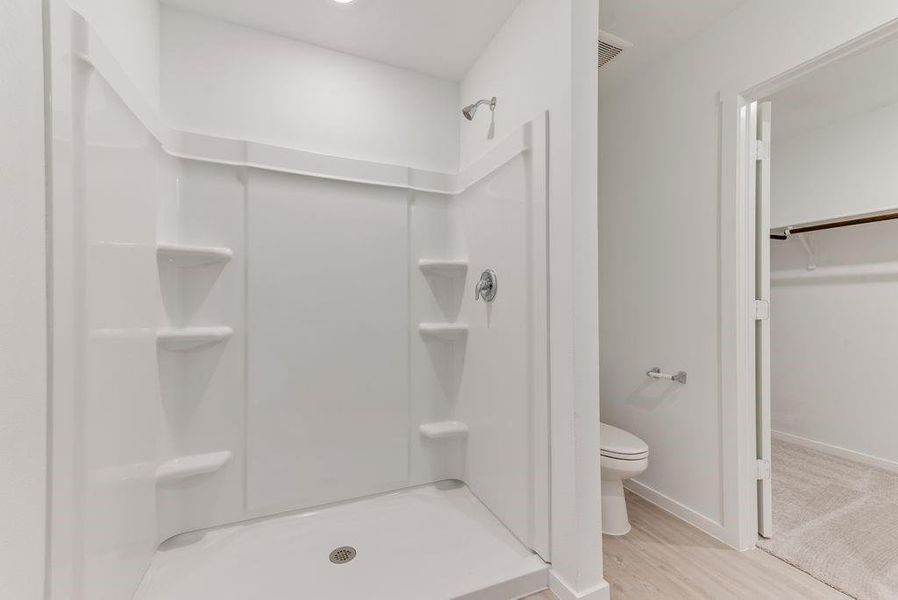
[718,19,898,550]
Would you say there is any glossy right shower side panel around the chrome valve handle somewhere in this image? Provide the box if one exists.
[453,138,548,559]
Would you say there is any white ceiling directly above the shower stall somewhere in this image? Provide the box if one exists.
[162,0,520,81]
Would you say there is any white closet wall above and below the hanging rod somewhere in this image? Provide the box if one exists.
[771,104,898,463]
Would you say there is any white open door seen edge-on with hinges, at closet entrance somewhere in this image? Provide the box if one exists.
[749,102,773,538]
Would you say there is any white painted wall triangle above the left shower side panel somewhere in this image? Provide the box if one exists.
[68,0,161,106]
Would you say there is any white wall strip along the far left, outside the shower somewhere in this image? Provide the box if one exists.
[0,0,48,600]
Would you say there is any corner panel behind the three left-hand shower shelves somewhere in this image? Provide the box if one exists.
[157,157,246,540]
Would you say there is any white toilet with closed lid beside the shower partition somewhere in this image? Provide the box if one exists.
[601,423,649,535]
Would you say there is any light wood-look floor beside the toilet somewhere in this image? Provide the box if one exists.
[526,493,849,600]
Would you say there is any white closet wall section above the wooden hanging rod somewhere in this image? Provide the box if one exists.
[770,102,898,227]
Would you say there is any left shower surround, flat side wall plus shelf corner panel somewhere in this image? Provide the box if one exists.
[51,10,245,600]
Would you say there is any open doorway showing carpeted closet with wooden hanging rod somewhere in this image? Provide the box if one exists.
[723,25,898,598]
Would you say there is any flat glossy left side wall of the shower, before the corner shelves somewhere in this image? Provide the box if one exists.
[63,67,162,600]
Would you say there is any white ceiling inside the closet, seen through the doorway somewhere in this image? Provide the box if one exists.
[768,35,898,138]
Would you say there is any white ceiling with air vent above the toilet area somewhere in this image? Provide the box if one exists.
[599,0,744,89]
